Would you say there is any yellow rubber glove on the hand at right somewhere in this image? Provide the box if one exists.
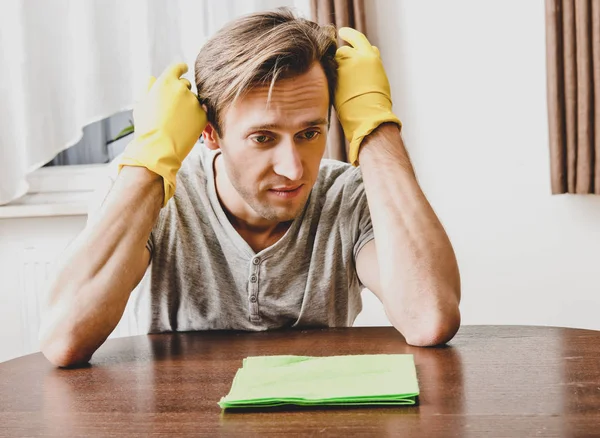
[335,27,402,166]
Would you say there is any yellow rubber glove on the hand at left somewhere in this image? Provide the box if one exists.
[119,64,206,206]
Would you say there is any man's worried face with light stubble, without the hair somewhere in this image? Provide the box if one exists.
[219,63,329,222]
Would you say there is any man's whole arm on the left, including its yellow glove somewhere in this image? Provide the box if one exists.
[40,64,206,366]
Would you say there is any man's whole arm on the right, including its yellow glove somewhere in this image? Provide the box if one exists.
[335,28,460,346]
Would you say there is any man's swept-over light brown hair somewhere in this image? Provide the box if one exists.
[195,8,337,136]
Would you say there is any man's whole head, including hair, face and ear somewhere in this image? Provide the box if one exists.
[196,9,337,222]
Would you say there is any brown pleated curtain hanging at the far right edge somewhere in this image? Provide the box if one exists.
[546,0,600,194]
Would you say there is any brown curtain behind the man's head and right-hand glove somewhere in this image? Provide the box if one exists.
[311,0,368,162]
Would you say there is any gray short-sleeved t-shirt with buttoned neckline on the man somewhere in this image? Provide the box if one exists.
[137,144,373,332]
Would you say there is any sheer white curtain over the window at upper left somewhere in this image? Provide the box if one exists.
[0,0,310,205]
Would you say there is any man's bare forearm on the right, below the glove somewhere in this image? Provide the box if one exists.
[359,124,460,345]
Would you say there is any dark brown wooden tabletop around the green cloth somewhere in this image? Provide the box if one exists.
[0,326,600,437]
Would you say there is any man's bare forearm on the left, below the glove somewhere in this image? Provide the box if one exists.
[40,167,163,366]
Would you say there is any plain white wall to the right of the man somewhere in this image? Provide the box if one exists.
[361,0,600,329]
